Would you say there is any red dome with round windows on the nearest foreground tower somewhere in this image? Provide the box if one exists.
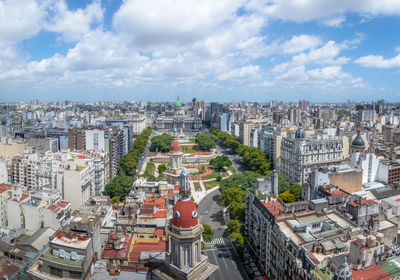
[172,197,199,228]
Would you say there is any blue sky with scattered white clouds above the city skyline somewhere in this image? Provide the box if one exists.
[0,0,400,102]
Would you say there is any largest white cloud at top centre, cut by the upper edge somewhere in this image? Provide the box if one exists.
[113,0,242,47]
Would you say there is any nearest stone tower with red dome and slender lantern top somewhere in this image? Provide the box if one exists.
[154,168,217,280]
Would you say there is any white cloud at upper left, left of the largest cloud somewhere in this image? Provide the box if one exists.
[46,0,103,42]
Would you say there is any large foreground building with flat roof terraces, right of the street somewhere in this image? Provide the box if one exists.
[245,191,363,280]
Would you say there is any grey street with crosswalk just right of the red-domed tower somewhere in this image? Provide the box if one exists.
[198,190,249,280]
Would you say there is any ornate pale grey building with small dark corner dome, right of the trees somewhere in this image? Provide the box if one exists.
[279,125,344,184]
